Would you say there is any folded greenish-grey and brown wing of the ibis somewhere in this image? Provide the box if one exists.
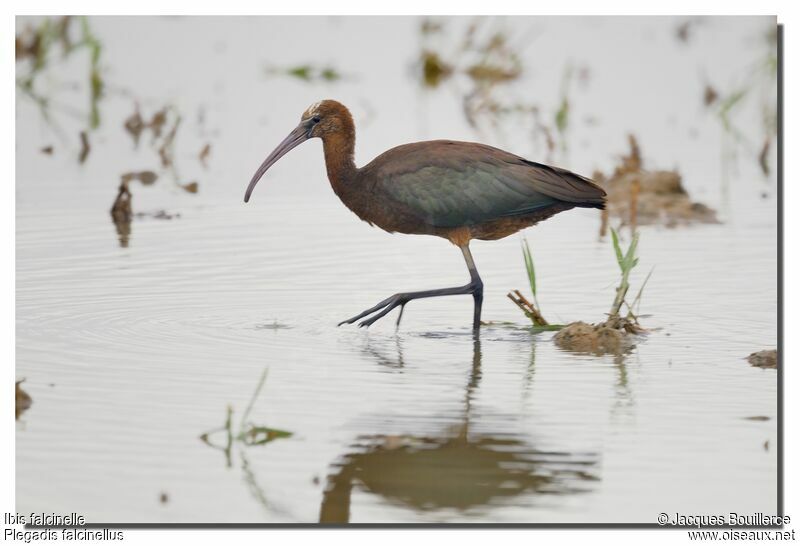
[365,140,605,227]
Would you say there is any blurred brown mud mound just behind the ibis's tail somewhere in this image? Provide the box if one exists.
[594,135,719,227]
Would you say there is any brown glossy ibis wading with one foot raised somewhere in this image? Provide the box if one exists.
[244,100,606,330]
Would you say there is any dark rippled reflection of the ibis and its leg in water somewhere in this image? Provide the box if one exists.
[319,335,598,523]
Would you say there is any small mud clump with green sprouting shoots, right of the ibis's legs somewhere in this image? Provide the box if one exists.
[553,229,652,355]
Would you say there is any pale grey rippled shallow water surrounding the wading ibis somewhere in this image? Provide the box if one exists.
[16,14,778,523]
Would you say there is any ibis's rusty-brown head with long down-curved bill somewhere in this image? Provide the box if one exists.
[244,100,353,203]
